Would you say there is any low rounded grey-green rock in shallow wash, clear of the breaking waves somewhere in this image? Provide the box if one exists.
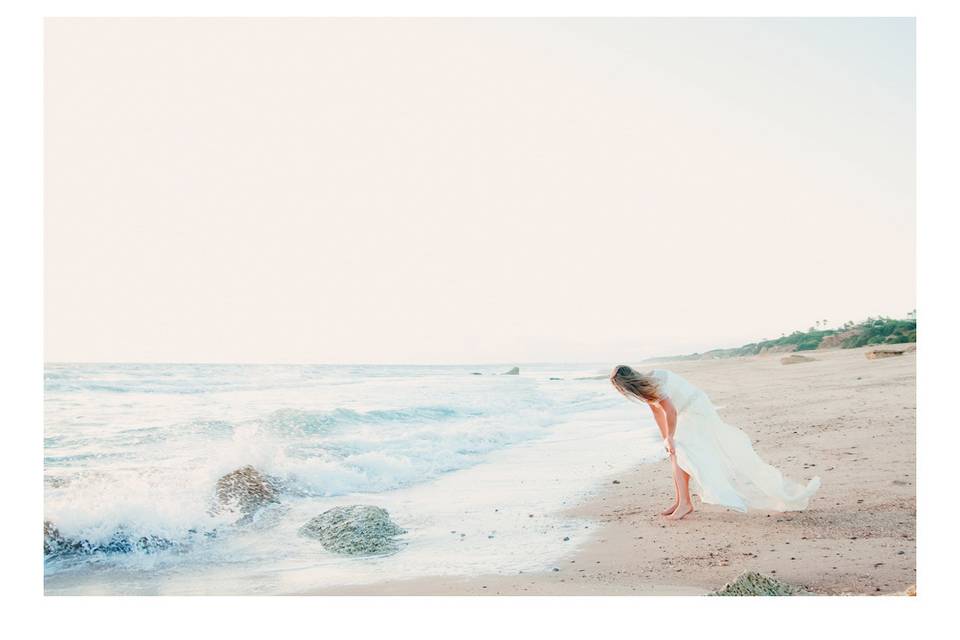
[300,504,406,556]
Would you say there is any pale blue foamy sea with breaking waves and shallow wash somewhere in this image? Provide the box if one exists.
[44,364,661,594]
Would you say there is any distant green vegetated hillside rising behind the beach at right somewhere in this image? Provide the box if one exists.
[646,312,917,362]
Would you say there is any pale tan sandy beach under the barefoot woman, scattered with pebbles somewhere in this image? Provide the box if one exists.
[320,349,916,595]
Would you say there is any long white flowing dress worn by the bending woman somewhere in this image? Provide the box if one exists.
[653,369,820,511]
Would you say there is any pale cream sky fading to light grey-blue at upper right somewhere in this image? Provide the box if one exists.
[45,18,916,363]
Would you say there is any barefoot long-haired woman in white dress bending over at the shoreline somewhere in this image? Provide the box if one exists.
[610,365,820,520]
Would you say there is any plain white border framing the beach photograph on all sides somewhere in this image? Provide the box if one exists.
[0,0,960,639]
